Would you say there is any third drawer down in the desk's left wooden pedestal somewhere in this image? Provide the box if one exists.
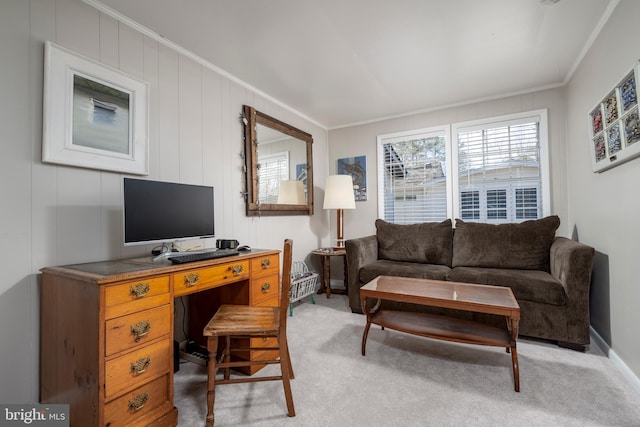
[105,339,173,400]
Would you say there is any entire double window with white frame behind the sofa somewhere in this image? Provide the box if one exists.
[378,110,550,224]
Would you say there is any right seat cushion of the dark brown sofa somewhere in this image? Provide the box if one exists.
[447,267,567,305]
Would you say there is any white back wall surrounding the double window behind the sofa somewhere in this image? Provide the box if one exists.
[329,89,573,239]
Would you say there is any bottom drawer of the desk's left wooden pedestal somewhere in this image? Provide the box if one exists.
[104,374,171,427]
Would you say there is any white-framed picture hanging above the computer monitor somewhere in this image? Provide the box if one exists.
[42,42,149,175]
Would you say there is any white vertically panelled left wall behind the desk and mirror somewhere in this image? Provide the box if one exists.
[0,0,329,403]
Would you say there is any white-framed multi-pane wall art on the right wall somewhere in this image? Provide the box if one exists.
[588,63,640,172]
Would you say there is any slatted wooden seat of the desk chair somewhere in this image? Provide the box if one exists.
[203,304,280,337]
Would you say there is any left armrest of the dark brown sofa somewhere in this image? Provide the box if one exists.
[345,235,378,312]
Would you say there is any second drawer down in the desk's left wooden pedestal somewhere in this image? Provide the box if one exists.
[105,304,172,356]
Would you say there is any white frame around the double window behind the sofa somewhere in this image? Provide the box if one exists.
[377,109,551,223]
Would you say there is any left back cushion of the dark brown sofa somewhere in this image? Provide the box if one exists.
[376,219,453,267]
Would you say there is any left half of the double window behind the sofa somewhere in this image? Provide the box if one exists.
[378,128,449,224]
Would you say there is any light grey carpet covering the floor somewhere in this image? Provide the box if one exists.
[174,295,640,427]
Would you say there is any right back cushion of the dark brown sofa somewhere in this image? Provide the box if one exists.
[453,215,560,272]
